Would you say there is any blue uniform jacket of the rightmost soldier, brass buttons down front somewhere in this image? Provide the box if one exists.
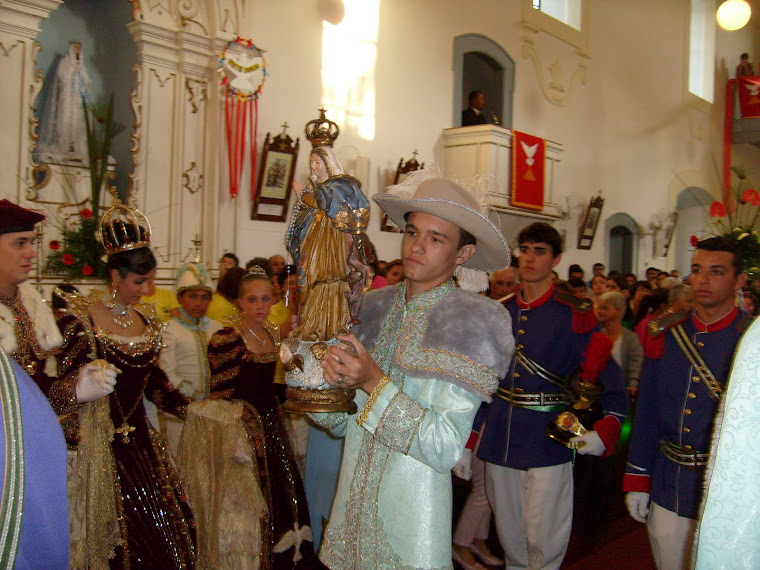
[623,308,747,519]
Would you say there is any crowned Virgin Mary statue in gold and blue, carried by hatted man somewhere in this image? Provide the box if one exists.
[280,109,374,411]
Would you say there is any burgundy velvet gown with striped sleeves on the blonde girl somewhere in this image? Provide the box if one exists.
[209,323,323,569]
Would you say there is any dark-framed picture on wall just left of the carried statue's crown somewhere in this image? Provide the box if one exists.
[251,127,300,222]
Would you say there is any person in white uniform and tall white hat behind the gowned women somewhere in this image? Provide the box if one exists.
[158,262,222,455]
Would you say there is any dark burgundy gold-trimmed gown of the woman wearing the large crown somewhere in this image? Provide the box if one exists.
[50,303,194,568]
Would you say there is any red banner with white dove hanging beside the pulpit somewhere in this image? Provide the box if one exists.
[512,131,546,210]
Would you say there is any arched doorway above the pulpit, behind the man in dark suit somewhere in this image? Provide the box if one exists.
[452,34,515,129]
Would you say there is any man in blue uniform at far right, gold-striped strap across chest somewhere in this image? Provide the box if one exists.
[623,237,749,569]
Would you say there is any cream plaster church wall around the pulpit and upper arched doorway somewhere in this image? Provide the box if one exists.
[4,0,760,282]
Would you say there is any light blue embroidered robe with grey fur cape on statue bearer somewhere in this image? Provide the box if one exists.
[314,281,514,570]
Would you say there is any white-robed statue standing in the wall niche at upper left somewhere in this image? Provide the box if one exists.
[36,41,90,164]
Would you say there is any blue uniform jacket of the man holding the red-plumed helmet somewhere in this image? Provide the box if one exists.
[478,286,628,469]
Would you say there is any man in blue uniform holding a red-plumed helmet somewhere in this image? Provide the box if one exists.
[478,223,628,568]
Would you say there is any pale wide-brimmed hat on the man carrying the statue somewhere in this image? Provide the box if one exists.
[373,178,511,271]
